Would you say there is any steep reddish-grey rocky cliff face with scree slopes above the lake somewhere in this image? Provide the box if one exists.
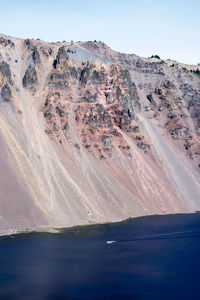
[0,36,200,232]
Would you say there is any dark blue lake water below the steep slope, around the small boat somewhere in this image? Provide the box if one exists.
[0,213,200,300]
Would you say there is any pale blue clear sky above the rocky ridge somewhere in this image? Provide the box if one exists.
[0,0,200,64]
